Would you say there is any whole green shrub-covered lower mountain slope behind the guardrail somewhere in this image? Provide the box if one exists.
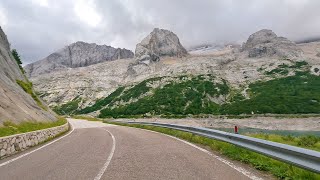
[72,61,320,118]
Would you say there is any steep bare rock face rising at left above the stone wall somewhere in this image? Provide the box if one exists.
[0,28,56,126]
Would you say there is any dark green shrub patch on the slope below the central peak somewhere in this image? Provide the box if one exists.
[99,74,229,118]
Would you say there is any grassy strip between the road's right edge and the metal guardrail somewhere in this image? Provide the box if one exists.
[106,122,320,179]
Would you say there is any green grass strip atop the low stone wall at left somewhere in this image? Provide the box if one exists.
[0,118,67,137]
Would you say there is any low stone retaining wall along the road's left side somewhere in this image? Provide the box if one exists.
[0,123,69,159]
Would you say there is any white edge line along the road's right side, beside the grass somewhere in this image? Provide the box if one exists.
[120,126,263,180]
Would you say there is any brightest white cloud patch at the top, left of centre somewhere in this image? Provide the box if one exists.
[74,0,102,27]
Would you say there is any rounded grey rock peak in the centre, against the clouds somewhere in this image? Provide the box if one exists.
[135,28,188,64]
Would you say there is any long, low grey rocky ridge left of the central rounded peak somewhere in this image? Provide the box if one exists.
[24,41,134,77]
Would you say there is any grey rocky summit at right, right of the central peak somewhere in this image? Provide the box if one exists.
[241,29,302,59]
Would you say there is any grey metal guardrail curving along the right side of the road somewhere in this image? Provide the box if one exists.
[121,121,320,173]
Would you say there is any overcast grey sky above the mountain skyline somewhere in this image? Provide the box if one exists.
[0,0,320,64]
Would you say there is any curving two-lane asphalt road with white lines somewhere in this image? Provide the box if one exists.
[0,119,259,180]
